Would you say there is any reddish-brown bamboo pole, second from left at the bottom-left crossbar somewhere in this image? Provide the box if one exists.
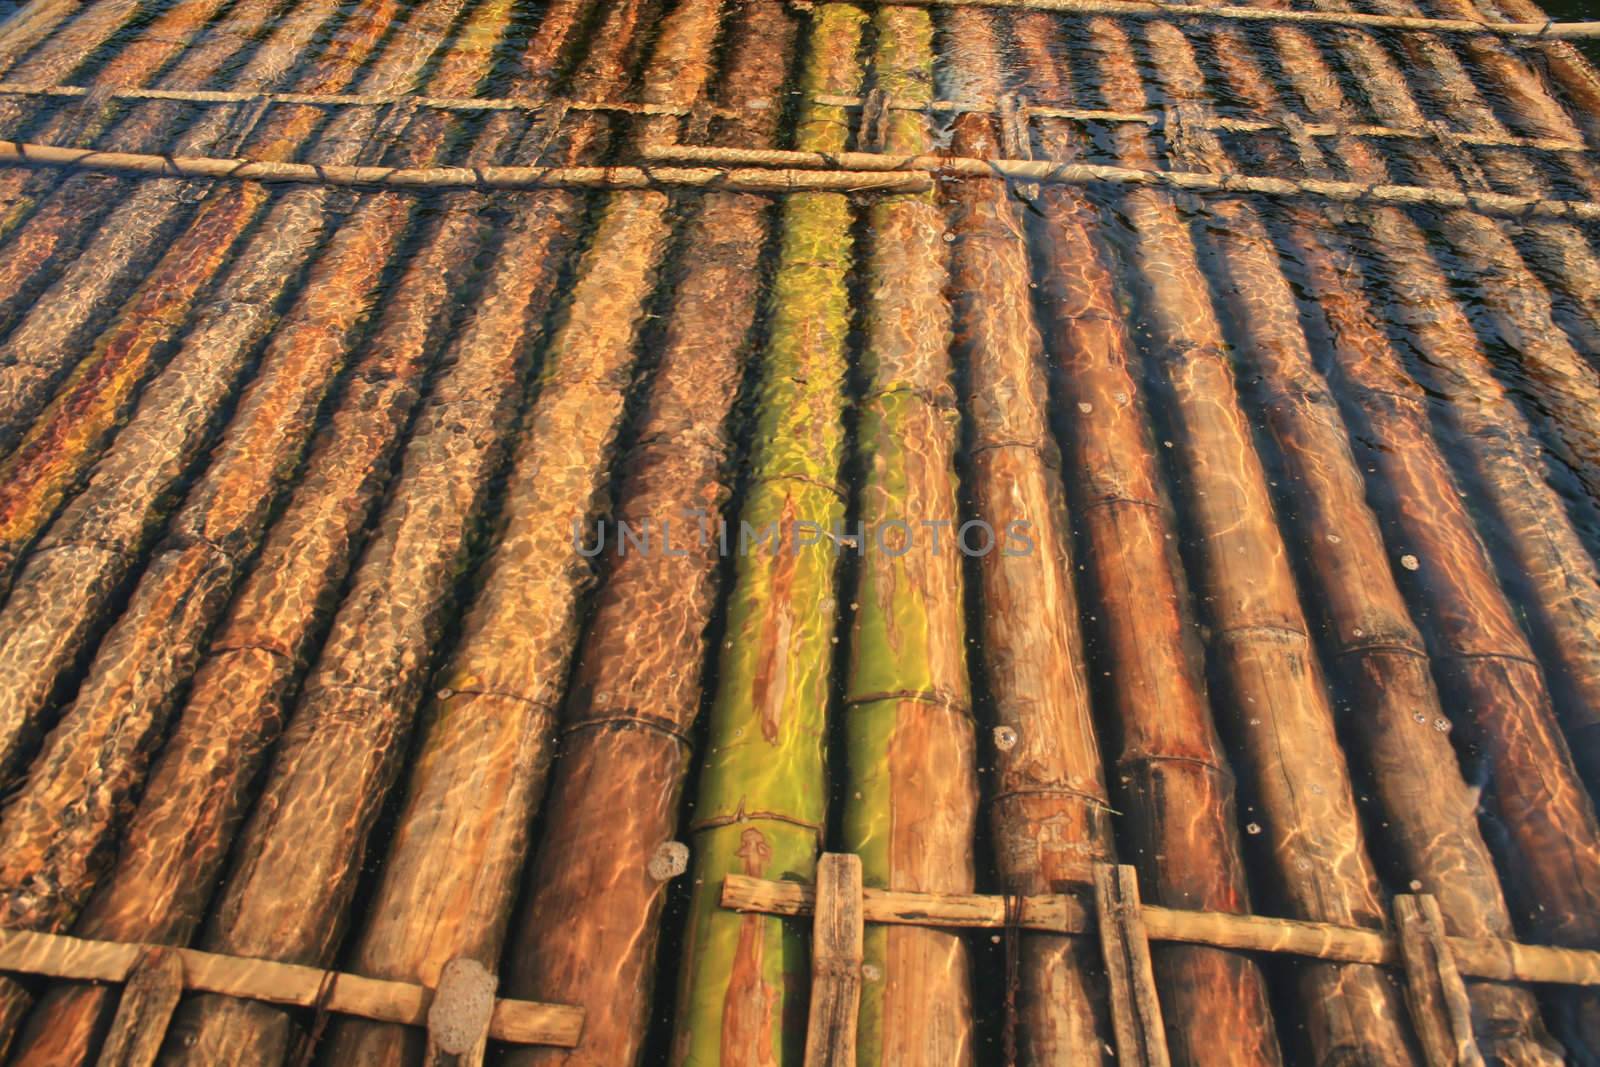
[1,0,604,1064]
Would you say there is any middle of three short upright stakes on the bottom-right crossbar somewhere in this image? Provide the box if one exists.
[1094,864,1171,1067]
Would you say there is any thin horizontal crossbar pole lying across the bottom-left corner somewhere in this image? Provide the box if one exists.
[0,929,584,1048]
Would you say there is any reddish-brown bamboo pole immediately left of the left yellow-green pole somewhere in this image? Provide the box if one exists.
[489,0,797,1067]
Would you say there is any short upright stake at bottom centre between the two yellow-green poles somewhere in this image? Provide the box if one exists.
[805,853,866,1067]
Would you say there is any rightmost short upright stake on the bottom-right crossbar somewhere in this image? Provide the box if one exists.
[1394,894,1483,1067]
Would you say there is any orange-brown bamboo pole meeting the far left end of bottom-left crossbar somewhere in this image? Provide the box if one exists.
[0,5,521,1062]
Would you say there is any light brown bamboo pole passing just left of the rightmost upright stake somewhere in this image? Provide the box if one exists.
[1056,12,1411,1064]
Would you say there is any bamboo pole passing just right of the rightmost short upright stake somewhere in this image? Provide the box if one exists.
[1149,14,1557,1062]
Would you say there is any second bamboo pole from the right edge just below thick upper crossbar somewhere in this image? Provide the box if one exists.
[1334,19,1600,511]
